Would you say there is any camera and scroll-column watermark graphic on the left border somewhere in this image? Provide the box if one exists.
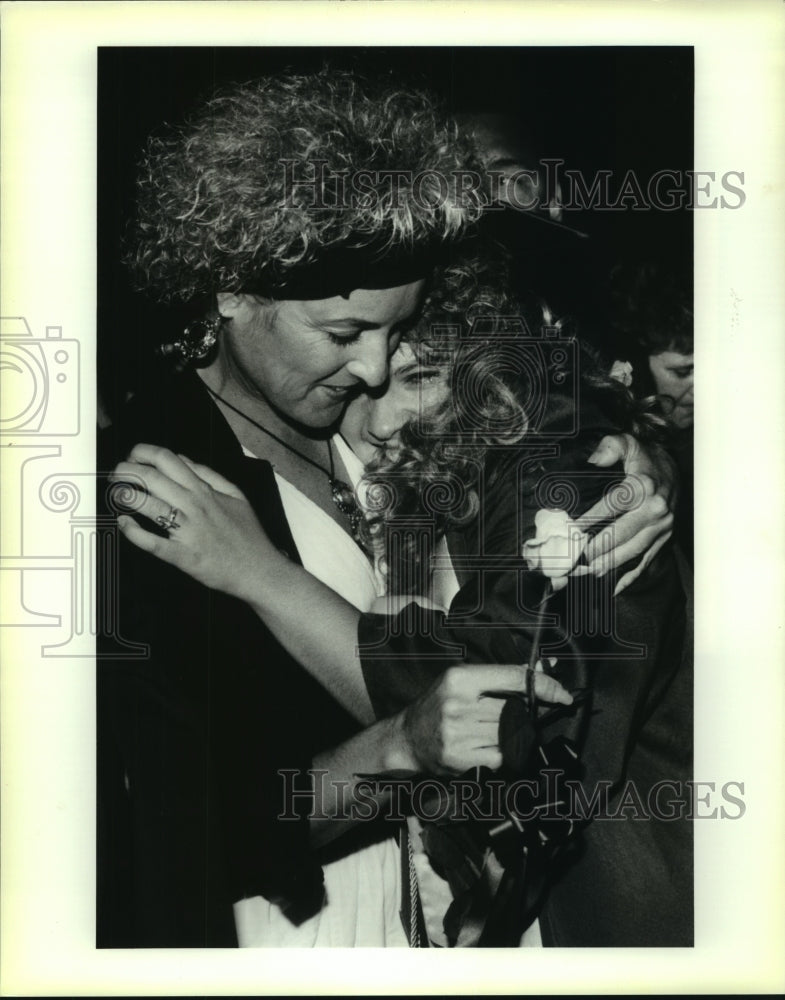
[0,316,147,658]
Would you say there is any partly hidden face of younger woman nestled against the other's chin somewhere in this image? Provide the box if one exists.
[341,343,450,465]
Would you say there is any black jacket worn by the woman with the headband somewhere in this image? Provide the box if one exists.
[97,375,358,947]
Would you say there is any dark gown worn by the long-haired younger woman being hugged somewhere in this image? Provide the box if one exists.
[360,378,693,946]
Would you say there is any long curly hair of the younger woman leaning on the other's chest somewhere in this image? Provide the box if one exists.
[363,244,527,593]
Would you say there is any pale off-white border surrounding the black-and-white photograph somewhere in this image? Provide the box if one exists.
[0,0,785,996]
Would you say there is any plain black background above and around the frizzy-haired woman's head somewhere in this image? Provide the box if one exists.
[97,47,694,415]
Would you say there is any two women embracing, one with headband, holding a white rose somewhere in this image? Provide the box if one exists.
[97,70,692,947]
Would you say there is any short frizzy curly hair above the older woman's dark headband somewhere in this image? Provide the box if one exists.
[125,70,483,303]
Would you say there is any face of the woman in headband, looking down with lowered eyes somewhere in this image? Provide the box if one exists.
[213,281,425,428]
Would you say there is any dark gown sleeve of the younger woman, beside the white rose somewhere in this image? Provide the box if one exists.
[358,392,648,760]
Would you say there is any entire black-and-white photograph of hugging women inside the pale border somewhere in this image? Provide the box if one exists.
[97,47,692,947]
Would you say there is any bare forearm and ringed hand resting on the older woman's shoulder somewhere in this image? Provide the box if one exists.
[113,444,375,725]
